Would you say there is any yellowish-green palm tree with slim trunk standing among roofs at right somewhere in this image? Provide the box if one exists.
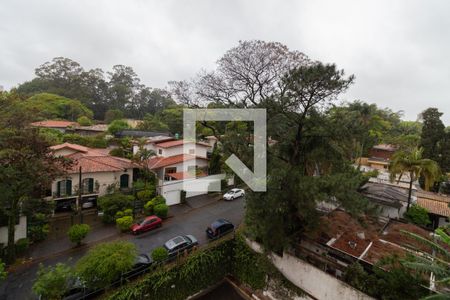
[389,148,441,211]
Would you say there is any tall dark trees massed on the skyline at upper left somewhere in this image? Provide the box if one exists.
[17,57,174,119]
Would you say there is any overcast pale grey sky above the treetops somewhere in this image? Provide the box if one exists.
[0,0,450,125]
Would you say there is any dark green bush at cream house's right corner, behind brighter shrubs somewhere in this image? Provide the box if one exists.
[98,193,134,224]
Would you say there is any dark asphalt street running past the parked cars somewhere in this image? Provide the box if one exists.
[0,199,244,300]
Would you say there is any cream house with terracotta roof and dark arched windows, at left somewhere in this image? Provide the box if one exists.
[46,143,137,211]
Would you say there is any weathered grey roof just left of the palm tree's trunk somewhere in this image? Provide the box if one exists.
[360,182,408,208]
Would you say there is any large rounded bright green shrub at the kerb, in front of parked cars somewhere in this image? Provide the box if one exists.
[75,241,137,288]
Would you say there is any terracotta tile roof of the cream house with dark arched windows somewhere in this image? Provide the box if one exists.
[51,143,136,174]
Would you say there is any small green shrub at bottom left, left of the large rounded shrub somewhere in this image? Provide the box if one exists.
[33,263,73,299]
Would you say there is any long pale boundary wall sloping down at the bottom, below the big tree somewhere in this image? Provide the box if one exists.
[247,240,373,300]
